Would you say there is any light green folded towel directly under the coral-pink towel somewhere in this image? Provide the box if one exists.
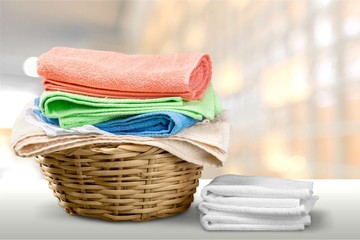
[40,85,222,128]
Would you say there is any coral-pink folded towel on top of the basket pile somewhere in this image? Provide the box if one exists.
[38,47,212,100]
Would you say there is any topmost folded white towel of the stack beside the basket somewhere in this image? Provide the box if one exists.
[201,174,313,199]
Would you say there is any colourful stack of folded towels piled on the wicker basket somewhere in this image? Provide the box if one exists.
[12,47,229,165]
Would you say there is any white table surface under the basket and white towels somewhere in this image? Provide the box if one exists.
[0,179,360,239]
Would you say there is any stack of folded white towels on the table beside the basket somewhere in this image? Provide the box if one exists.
[199,175,318,231]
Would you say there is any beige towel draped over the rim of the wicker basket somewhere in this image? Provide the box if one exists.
[11,103,230,166]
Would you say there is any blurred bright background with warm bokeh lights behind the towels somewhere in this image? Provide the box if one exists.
[0,0,360,178]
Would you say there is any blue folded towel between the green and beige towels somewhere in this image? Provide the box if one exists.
[33,98,199,137]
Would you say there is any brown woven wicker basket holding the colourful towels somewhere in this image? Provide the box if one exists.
[37,144,202,221]
